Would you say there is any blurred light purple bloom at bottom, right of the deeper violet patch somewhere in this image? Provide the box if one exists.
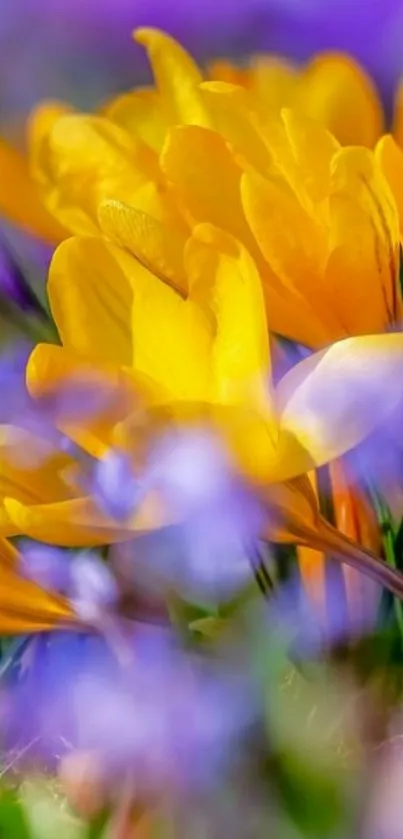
[70,630,252,794]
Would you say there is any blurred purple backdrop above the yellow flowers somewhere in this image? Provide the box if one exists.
[0,0,403,141]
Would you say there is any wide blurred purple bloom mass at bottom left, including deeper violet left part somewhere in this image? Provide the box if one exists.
[3,628,252,796]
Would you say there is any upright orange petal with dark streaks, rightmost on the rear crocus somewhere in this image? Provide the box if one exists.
[329,148,401,333]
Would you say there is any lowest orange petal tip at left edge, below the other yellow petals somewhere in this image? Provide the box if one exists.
[0,539,74,635]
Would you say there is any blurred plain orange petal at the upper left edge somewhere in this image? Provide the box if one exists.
[0,140,66,244]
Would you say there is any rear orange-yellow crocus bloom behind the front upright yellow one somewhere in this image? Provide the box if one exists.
[21,30,401,348]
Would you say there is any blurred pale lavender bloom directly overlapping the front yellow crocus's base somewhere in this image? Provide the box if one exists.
[113,429,262,602]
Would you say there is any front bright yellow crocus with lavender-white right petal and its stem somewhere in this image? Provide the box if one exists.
[4,223,403,604]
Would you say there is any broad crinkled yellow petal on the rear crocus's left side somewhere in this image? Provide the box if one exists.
[33,114,158,235]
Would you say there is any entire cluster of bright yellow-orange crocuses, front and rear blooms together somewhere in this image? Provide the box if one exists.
[0,29,403,626]
